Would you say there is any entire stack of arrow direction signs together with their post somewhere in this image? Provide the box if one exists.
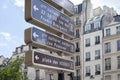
[24,0,75,77]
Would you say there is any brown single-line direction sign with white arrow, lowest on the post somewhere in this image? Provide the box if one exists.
[25,51,74,72]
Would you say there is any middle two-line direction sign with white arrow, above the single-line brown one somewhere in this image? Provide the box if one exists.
[25,27,74,54]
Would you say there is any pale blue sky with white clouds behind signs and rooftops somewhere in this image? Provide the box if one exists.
[0,0,120,58]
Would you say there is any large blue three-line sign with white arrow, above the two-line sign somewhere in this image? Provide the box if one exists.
[25,0,74,38]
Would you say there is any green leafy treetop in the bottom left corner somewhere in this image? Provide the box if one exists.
[0,58,27,80]
